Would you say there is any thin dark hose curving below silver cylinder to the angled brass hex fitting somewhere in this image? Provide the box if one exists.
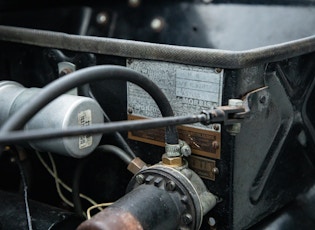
[72,145,133,216]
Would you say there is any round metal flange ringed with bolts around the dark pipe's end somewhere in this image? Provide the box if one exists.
[127,165,216,229]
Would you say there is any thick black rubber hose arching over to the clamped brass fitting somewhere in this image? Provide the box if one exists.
[0,65,178,144]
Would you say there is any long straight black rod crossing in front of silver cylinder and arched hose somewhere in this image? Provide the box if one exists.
[0,114,207,144]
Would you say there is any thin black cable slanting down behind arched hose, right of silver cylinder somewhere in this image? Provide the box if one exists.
[78,84,136,158]
